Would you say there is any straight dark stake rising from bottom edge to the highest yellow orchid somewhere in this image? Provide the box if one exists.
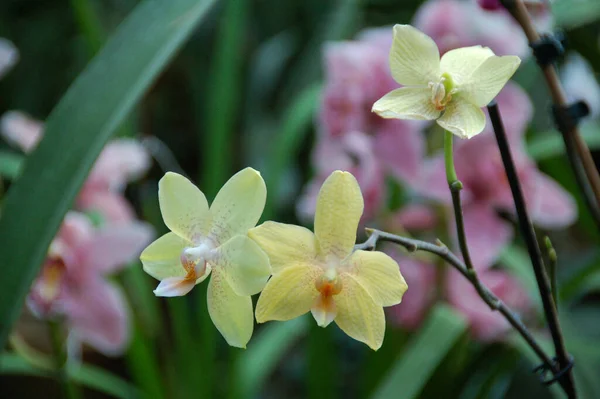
[487,103,577,398]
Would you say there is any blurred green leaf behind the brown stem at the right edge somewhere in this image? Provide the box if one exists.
[527,122,600,161]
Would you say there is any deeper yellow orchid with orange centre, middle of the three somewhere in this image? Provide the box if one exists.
[248,171,407,350]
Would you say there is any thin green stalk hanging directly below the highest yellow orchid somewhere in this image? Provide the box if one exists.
[444,131,474,273]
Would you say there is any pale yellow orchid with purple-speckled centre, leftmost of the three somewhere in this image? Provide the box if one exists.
[140,168,271,348]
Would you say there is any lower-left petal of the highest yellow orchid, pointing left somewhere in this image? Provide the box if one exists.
[372,87,440,120]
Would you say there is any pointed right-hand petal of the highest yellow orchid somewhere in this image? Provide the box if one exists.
[459,55,521,107]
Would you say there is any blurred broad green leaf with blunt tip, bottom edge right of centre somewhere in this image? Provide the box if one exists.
[373,305,467,399]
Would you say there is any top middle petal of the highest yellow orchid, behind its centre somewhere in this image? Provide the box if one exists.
[440,46,494,85]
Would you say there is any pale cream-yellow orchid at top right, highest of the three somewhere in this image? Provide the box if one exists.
[373,25,521,138]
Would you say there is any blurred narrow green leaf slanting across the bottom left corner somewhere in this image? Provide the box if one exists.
[0,353,140,399]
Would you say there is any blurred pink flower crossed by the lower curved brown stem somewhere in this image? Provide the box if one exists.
[446,270,532,341]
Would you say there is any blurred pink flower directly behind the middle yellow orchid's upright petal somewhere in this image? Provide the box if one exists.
[297,132,385,220]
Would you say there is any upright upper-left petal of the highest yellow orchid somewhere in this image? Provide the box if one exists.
[390,25,440,85]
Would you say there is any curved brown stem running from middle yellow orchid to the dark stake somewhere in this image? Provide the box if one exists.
[355,229,558,373]
